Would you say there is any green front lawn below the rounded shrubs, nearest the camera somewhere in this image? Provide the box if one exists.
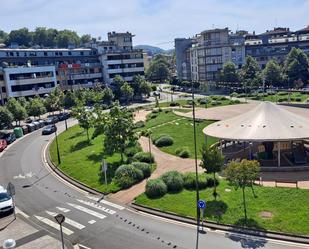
[136,180,309,235]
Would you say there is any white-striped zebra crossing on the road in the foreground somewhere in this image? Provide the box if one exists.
[33,196,124,236]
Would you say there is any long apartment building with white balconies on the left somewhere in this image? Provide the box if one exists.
[0,32,146,104]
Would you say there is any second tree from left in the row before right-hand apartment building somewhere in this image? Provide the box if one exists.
[241,56,261,86]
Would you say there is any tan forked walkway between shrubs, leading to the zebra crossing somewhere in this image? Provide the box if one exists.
[110,137,203,204]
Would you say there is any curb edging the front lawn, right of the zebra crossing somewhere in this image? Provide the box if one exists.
[129,203,309,245]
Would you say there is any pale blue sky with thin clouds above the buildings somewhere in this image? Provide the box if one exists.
[0,0,309,49]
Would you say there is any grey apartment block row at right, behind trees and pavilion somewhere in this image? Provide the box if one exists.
[175,26,309,82]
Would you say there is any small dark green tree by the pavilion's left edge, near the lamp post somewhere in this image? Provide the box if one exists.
[201,145,224,199]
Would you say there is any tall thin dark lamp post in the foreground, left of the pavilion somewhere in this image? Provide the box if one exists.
[192,83,200,249]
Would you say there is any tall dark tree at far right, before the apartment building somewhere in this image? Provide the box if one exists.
[284,48,309,87]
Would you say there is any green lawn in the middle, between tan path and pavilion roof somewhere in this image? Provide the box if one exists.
[143,111,217,158]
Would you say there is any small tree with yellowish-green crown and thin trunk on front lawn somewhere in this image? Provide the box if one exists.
[224,159,260,221]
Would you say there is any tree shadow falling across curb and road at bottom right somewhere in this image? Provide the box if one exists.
[226,218,267,249]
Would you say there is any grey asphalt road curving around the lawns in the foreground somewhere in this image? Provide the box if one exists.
[0,119,309,249]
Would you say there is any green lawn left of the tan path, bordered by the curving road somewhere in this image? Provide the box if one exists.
[50,125,120,193]
